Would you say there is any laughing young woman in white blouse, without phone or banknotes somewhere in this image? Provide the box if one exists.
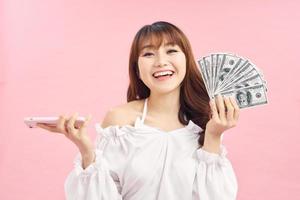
[40,21,239,200]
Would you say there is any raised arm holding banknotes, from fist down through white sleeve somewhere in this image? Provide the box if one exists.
[194,95,239,200]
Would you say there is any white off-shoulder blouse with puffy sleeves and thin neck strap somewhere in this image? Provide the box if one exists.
[65,99,238,200]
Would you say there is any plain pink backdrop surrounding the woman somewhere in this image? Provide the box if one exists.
[0,0,300,200]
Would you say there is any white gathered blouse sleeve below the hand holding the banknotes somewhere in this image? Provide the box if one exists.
[194,144,238,200]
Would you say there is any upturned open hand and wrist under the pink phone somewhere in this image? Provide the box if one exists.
[37,113,93,155]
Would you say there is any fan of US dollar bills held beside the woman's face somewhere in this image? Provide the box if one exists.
[198,53,268,108]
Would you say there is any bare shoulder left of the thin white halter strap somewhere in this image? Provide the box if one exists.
[101,100,144,128]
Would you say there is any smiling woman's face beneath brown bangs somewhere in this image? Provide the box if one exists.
[138,41,186,93]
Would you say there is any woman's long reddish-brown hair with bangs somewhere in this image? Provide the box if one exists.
[127,21,210,147]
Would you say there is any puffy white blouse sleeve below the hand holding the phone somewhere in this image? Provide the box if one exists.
[64,124,122,200]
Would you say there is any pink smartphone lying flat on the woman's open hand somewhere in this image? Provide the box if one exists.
[24,117,85,128]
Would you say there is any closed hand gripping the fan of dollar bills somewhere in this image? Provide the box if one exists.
[205,95,240,138]
